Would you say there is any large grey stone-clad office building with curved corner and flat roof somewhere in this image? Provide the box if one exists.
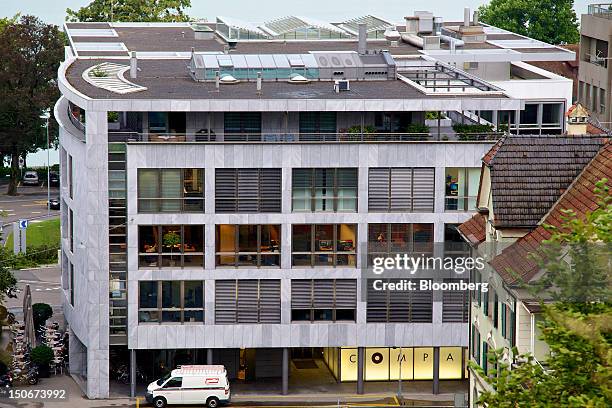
[55,10,574,398]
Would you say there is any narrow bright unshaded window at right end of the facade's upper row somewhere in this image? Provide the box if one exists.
[444,167,480,211]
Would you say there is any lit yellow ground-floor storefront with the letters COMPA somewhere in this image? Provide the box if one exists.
[323,347,467,382]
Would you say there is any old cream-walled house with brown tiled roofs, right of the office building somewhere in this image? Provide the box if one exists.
[459,136,612,406]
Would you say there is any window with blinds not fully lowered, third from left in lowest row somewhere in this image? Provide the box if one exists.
[291,279,357,322]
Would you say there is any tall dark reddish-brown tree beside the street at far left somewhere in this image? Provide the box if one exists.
[0,16,64,195]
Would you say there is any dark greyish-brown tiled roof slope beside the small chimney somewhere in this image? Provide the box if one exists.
[483,135,604,228]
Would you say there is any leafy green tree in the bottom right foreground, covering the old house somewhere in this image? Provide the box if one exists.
[470,180,612,408]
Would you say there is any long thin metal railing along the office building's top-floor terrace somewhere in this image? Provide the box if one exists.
[108,131,504,143]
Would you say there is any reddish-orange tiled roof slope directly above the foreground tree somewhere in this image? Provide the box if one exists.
[490,143,612,283]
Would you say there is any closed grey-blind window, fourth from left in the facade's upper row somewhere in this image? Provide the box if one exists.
[368,167,435,212]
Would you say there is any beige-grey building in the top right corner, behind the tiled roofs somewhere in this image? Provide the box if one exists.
[578,3,612,129]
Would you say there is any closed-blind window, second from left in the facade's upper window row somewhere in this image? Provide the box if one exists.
[215,169,282,213]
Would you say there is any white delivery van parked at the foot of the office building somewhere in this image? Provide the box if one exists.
[146,365,230,408]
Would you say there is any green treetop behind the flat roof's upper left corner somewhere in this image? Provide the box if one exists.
[66,0,191,22]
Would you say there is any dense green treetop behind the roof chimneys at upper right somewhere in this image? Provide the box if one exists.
[478,0,580,44]
